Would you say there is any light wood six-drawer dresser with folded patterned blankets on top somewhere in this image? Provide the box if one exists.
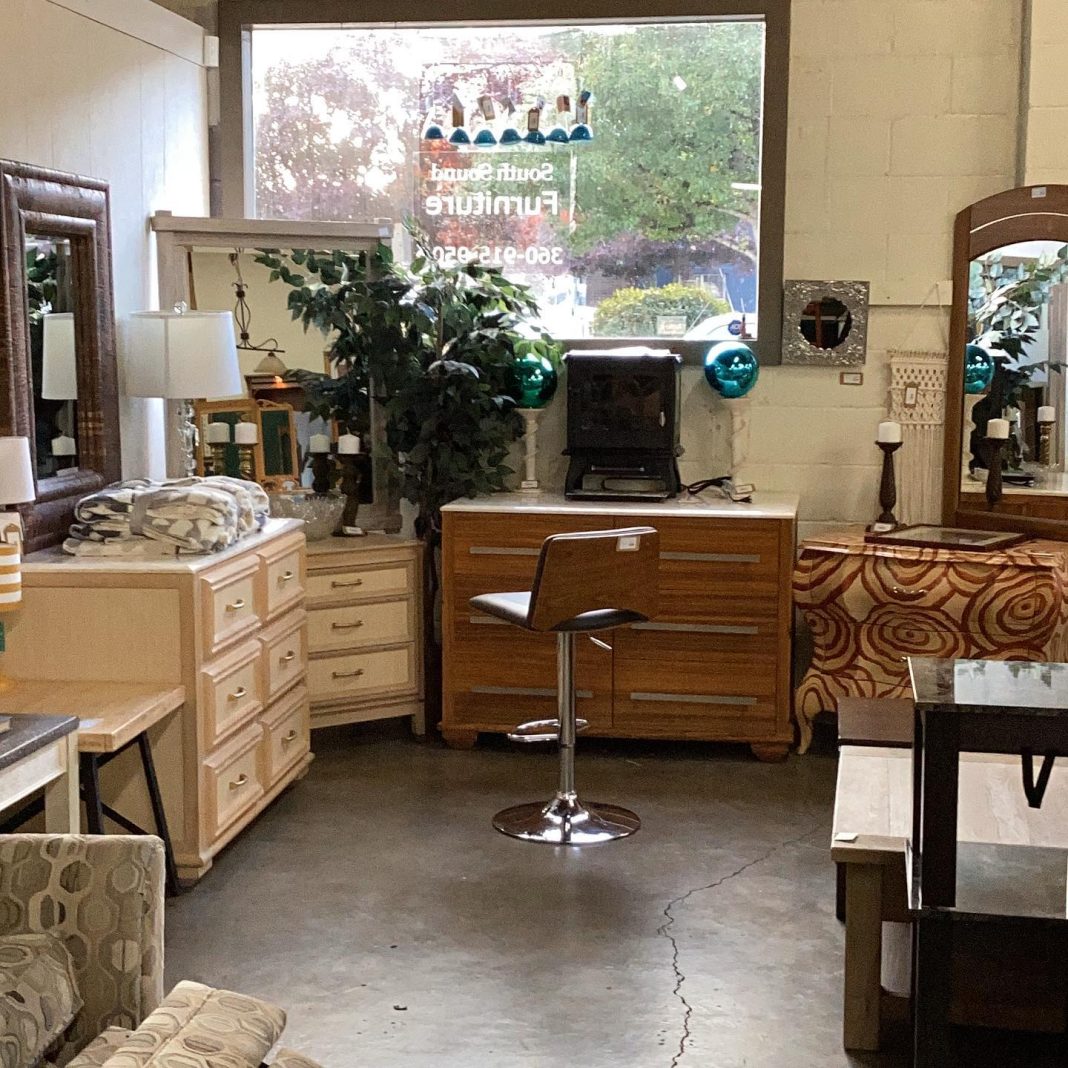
[0,519,312,879]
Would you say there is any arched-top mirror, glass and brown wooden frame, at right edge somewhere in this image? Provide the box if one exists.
[942,186,1068,539]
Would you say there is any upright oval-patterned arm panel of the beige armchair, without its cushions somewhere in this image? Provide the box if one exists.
[0,834,163,1064]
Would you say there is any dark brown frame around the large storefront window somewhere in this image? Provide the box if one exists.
[213,0,790,365]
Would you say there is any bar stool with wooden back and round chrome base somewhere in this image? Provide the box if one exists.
[471,527,660,846]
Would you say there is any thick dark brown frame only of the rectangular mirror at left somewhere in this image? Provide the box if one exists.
[0,160,122,552]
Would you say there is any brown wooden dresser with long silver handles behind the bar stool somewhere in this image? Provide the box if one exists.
[441,493,797,759]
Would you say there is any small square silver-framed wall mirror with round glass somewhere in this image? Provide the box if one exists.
[783,281,868,366]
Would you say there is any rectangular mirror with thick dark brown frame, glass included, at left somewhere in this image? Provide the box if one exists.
[0,160,121,551]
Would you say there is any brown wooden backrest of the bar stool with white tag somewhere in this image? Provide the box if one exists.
[529,527,660,630]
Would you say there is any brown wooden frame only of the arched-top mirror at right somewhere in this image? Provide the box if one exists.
[942,186,1068,540]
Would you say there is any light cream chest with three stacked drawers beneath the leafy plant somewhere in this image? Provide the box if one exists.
[308,534,426,735]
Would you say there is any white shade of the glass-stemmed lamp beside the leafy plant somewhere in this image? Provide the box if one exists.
[126,312,245,399]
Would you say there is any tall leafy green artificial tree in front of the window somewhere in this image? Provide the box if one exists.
[256,234,557,726]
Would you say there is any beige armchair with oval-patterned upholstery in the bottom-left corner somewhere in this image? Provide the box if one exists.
[0,834,317,1068]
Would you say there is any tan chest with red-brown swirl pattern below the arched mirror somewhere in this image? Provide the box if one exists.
[794,532,1068,753]
